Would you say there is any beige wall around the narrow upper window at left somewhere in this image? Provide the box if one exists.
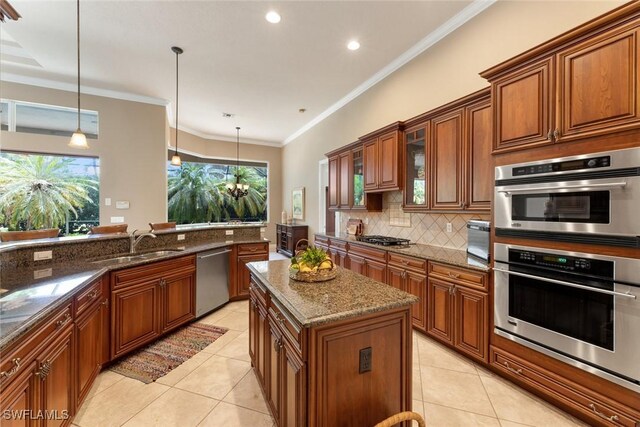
[0,81,167,231]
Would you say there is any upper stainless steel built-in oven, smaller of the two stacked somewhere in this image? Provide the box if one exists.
[494,148,640,247]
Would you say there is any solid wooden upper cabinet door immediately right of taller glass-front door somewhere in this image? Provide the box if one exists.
[431,109,464,210]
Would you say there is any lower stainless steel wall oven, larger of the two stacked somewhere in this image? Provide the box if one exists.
[494,243,640,391]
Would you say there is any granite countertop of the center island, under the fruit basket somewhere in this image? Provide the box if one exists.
[247,260,418,327]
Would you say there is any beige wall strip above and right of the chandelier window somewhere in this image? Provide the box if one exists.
[170,128,282,243]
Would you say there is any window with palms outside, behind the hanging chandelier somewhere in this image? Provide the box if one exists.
[167,152,268,224]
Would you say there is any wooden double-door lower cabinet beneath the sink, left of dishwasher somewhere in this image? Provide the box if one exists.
[111,256,195,359]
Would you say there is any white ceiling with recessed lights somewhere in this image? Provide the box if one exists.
[0,0,492,145]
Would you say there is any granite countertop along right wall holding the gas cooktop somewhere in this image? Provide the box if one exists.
[316,233,489,271]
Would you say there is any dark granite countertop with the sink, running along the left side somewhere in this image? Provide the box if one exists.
[0,238,268,352]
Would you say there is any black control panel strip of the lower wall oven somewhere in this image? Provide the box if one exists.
[509,249,614,278]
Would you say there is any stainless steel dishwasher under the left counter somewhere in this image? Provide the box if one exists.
[196,248,231,317]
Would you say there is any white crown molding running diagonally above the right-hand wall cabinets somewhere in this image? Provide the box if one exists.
[282,0,497,146]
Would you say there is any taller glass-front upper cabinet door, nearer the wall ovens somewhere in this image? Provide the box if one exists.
[404,122,430,209]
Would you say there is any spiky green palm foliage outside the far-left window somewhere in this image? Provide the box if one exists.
[0,154,98,230]
